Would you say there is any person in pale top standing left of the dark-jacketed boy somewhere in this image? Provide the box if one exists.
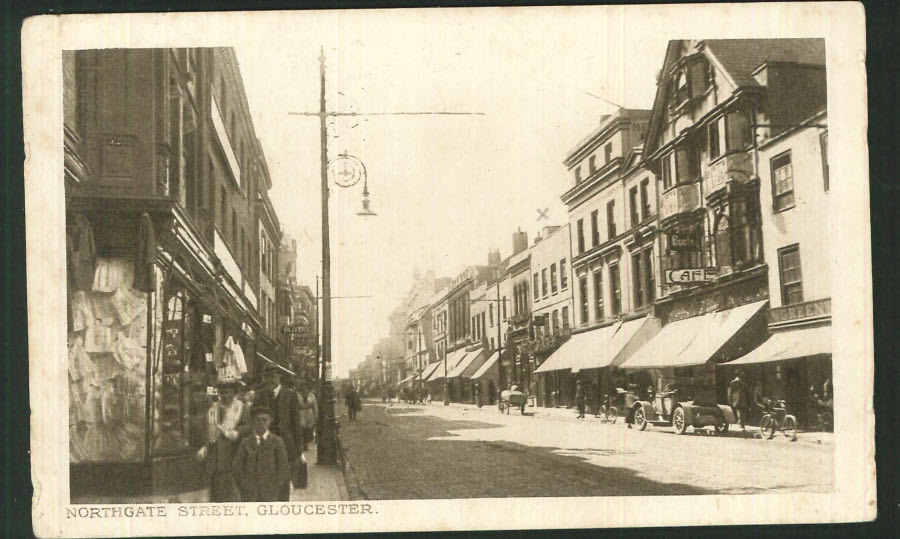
[197,379,251,503]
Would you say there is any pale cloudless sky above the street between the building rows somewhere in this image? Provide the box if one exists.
[233,8,678,376]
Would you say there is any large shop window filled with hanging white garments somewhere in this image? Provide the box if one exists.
[68,258,147,463]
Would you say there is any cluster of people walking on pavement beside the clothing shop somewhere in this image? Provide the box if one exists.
[197,365,318,502]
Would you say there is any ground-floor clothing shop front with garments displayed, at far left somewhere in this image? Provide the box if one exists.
[66,203,256,502]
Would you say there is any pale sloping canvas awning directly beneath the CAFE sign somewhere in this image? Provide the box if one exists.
[621,301,767,369]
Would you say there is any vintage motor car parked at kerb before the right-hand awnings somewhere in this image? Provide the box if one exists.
[634,372,734,434]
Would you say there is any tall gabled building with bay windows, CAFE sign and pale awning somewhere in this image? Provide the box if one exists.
[623,39,825,408]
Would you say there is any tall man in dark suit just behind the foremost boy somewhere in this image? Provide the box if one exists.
[256,365,305,498]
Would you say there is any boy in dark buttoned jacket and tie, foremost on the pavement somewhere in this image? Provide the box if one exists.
[232,404,291,502]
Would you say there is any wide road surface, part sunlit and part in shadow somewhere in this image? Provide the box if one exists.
[341,401,834,499]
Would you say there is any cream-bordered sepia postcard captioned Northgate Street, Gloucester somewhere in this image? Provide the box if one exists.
[23,4,874,536]
